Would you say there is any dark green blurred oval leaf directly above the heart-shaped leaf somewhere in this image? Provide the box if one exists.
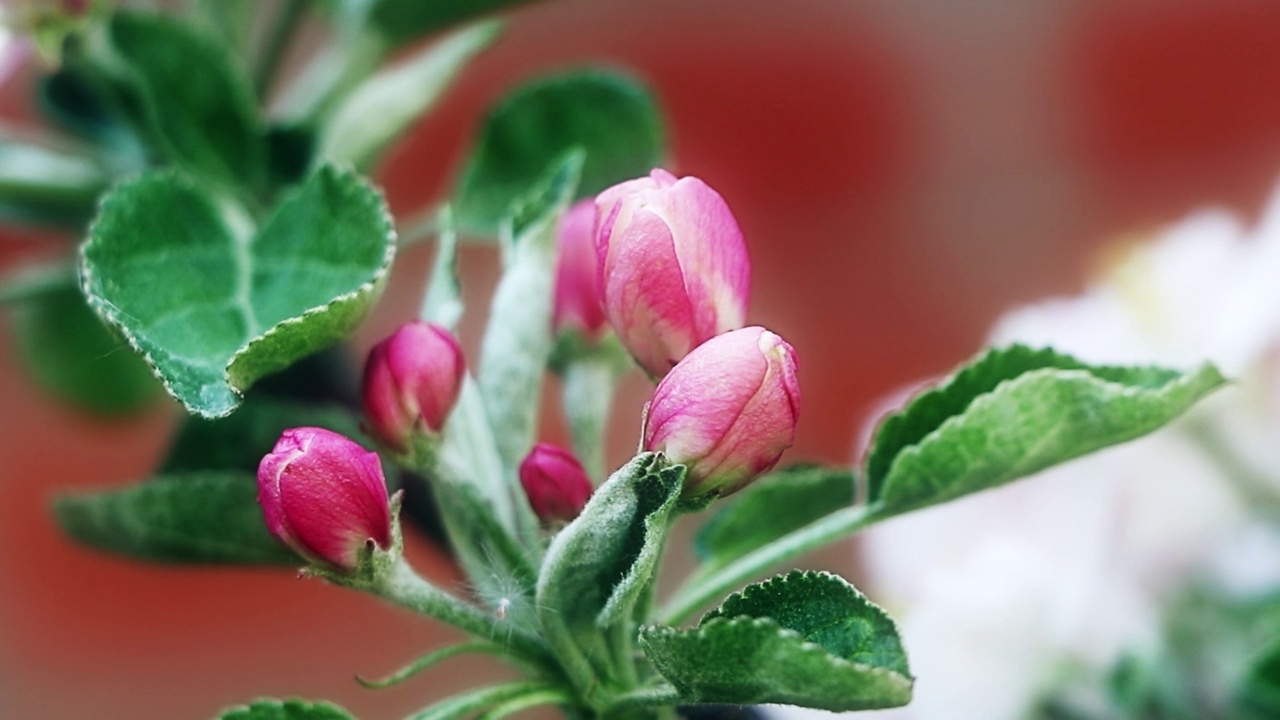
[109,12,266,184]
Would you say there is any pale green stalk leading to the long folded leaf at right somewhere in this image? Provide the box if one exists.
[658,505,879,625]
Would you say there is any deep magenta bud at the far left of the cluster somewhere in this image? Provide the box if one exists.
[257,428,392,570]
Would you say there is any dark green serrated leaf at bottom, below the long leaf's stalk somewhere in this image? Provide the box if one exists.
[640,571,913,712]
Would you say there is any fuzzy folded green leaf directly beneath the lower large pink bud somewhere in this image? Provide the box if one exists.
[536,452,685,656]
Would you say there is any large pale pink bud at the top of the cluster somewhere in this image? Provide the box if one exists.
[595,169,751,378]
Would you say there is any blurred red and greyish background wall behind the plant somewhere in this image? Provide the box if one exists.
[0,0,1280,720]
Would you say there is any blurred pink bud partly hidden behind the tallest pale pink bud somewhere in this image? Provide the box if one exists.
[552,200,608,340]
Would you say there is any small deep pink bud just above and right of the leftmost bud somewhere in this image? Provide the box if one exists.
[364,320,466,451]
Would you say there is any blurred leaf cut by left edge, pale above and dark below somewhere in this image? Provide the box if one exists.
[0,138,108,222]
